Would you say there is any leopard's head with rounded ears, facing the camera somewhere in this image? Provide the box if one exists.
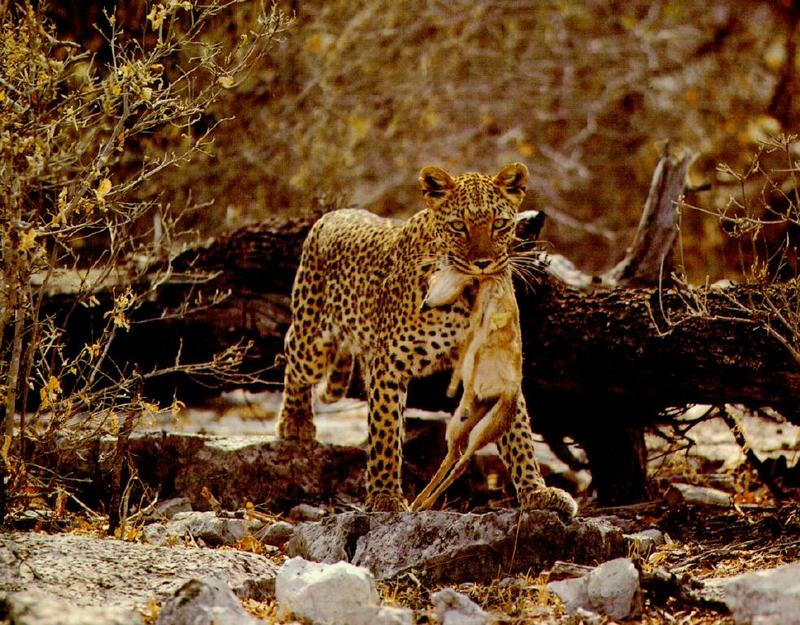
[419,163,528,276]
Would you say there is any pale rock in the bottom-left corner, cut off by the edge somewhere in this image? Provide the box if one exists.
[0,590,144,625]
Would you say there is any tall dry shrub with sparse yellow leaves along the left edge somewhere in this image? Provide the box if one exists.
[0,0,287,519]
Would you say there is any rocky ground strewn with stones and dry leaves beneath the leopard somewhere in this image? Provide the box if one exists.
[0,394,800,625]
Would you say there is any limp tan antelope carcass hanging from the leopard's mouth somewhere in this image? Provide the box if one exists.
[411,267,522,510]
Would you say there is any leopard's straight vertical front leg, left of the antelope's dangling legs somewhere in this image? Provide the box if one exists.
[366,357,408,512]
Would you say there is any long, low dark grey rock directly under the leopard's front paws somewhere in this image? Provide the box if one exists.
[286,510,624,583]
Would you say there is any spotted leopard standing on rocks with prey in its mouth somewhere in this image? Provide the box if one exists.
[276,163,577,518]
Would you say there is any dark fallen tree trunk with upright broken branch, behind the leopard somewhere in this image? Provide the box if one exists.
[29,154,800,504]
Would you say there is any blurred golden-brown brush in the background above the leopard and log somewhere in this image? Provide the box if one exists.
[48,0,800,281]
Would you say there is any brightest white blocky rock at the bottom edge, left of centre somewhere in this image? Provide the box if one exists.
[275,557,380,625]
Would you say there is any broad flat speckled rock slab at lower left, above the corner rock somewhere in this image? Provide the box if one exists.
[0,532,277,608]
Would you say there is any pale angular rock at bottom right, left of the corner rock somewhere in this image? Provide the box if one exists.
[547,558,641,619]
